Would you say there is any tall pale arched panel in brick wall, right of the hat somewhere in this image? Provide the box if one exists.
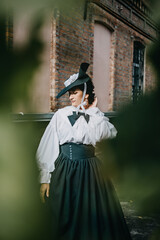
[93,23,111,112]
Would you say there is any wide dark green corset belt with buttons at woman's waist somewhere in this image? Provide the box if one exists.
[60,143,95,160]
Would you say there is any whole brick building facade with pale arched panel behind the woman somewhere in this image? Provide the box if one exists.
[8,0,158,113]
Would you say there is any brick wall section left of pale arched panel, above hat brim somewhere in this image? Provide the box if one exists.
[51,9,93,110]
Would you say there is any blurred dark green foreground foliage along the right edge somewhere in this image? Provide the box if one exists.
[101,15,160,239]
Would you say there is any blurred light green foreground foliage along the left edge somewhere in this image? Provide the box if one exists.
[0,0,85,240]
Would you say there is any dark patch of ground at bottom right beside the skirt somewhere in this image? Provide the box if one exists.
[121,201,160,240]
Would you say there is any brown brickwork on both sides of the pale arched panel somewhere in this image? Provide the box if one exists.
[50,1,156,111]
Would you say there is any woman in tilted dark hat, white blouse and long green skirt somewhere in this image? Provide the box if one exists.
[37,63,131,240]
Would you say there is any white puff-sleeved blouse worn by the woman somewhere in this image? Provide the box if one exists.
[36,106,117,183]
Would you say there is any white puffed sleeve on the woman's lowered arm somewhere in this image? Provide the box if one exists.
[36,112,59,183]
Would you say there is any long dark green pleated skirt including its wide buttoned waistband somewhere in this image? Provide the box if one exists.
[49,143,131,240]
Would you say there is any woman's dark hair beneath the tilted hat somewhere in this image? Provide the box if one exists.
[70,80,95,104]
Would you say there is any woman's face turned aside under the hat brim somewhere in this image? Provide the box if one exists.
[69,89,83,107]
